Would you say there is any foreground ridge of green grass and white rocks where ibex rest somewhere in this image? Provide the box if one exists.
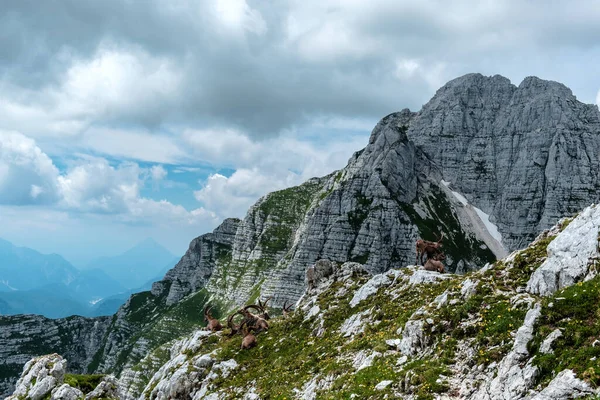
[7,205,600,400]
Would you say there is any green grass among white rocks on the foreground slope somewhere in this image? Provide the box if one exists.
[165,220,600,399]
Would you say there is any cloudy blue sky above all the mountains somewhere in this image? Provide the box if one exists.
[0,0,600,265]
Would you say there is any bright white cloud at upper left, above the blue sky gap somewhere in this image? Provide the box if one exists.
[0,44,182,137]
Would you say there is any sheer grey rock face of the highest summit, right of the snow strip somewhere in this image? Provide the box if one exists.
[408,74,600,250]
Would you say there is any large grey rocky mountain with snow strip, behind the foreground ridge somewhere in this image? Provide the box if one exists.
[0,74,600,398]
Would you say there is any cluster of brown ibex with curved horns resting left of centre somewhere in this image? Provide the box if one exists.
[204,298,292,350]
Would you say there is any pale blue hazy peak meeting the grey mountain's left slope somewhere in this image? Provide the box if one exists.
[86,238,176,289]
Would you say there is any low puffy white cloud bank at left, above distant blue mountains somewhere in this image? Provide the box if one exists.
[0,132,217,230]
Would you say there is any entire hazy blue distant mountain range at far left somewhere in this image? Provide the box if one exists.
[0,239,178,318]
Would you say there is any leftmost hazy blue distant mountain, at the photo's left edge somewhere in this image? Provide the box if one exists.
[0,239,79,291]
